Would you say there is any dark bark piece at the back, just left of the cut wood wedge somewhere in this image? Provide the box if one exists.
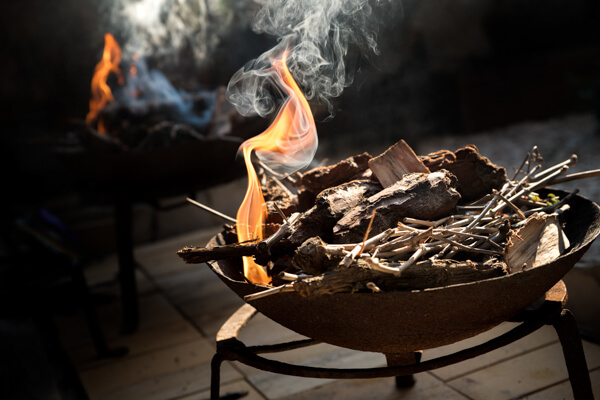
[297,153,372,194]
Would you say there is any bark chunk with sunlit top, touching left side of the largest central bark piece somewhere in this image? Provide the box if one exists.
[290,181,382,245]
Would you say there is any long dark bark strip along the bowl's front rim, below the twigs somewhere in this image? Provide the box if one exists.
[292,260,508,297]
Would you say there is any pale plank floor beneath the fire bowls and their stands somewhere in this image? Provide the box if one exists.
[57,228,600,400]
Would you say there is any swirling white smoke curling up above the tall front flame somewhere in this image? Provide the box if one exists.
[227,0,391,117]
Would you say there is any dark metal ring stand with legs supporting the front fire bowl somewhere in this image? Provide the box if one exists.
[211,281,593,400]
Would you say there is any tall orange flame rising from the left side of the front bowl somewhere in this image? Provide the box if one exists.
[237,51,317,284]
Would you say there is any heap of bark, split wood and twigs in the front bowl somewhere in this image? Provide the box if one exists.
[179,142,595,300]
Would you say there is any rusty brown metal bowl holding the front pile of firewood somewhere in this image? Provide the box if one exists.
[209,190,600,354]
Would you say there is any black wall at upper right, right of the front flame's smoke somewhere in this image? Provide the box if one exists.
[314,0,600,155]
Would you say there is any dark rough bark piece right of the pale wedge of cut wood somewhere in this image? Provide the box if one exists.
[421,145,508,202]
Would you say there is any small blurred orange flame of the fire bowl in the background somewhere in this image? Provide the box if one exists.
[85,33,123,133]
